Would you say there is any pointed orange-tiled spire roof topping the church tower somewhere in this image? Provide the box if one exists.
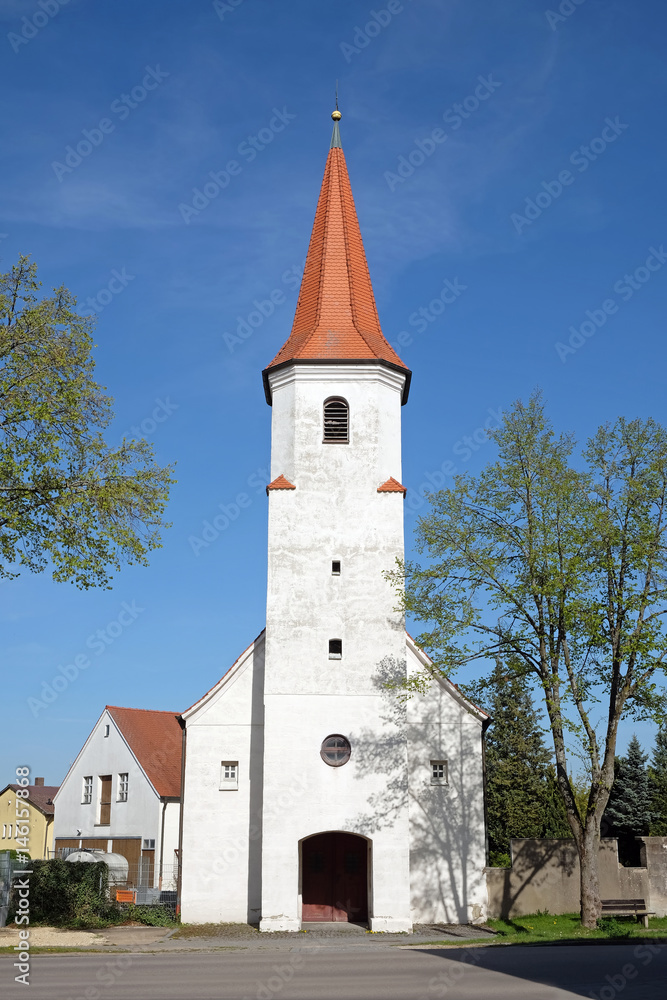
[262,110,411,405]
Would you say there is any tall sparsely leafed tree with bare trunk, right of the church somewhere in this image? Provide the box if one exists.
[394,394,667,927]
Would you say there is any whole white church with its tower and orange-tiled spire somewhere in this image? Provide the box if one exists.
[179,111,489,932]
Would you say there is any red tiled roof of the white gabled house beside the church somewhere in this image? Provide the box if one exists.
[106,705,183,799]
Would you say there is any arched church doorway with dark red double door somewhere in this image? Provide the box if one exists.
[301,832,369,923]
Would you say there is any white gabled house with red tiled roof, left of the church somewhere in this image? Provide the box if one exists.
[54,705,182,890]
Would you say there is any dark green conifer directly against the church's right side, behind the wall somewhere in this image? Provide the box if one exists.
[477,660,571,864]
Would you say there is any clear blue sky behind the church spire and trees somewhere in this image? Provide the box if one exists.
[0,0,667,784]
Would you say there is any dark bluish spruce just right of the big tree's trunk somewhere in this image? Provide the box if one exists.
[602,736,651,859]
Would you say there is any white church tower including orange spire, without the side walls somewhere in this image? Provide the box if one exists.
[261,111,411,930]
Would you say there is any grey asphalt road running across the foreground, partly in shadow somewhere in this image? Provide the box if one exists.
[0,943,667,1000]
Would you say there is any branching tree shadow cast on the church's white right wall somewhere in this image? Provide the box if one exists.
[342,657,486,923]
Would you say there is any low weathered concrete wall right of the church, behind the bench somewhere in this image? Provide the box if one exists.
[486,837,667,918]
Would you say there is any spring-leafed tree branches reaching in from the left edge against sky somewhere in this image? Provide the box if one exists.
[0,256,174,588]
